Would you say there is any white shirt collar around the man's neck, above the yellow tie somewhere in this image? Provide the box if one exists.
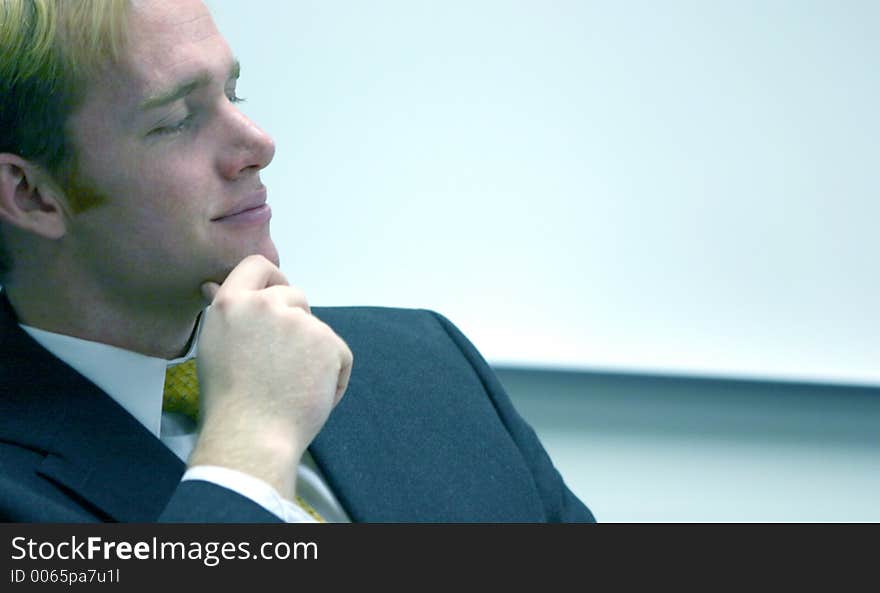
[19,315,204,437]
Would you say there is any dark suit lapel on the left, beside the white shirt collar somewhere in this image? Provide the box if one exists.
[0,293,184,522]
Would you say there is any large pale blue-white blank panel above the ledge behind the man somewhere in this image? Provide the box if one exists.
[209,0,880,384]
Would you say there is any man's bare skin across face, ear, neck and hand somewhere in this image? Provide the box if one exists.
[0,0,352,498]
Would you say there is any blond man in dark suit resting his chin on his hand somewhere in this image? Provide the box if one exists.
[0,0,592,522]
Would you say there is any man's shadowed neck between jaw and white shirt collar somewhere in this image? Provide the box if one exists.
[3,283,204,359]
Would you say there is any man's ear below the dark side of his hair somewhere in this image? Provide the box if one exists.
[0,153,67,239]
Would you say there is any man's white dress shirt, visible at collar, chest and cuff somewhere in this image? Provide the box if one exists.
[20,318,350,523]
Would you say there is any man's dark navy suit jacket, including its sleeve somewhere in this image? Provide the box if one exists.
[0,295,593,523]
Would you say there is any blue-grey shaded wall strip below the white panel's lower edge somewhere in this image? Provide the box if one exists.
[498,369,880,522]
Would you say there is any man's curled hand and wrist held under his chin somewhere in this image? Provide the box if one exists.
[189,255,352,499]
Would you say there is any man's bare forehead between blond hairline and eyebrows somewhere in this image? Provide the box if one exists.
[120,0,232,96]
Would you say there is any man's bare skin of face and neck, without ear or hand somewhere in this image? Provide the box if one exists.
[2,0,278,358]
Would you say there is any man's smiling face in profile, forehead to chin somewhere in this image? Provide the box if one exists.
[65,0,278,307]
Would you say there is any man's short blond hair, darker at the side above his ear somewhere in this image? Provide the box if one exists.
[0,0,129,278]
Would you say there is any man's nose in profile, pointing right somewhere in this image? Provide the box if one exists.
[219,105,275,180]
